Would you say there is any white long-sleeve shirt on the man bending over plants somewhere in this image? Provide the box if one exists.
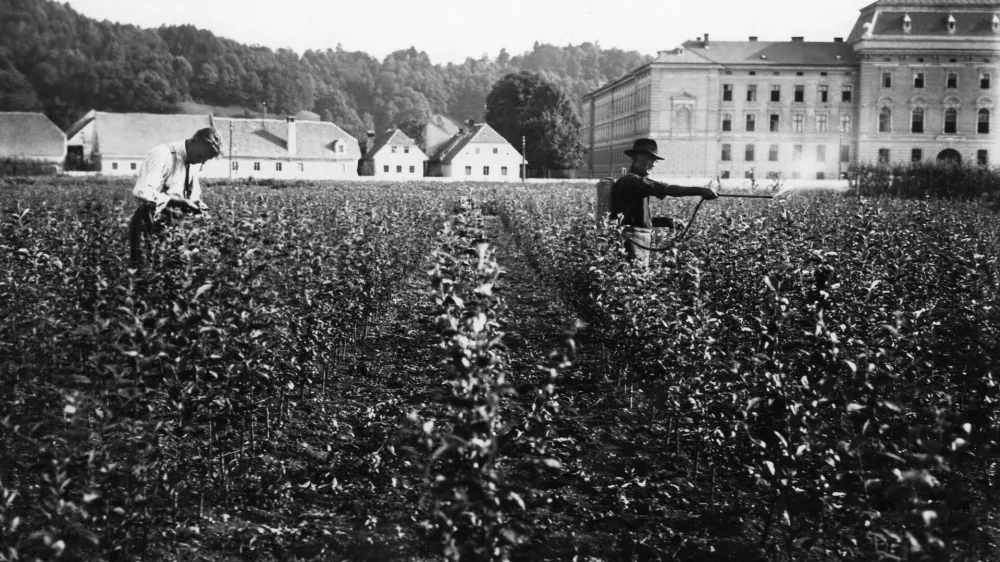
[132,141,201,213]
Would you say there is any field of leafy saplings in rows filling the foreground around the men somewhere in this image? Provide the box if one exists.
[0,178,1000,562]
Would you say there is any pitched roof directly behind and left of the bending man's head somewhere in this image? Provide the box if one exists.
[94,111,210,156]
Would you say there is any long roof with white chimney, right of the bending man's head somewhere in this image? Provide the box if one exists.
[213,118,361,160]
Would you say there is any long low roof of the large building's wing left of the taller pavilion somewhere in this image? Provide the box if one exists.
[680,41,855,66]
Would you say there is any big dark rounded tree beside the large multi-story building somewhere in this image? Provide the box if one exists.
[486,71,584,172]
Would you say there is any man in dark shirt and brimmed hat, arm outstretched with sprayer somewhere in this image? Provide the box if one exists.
[611,139,718,267]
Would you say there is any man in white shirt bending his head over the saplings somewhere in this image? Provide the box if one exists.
[129,127,222,267]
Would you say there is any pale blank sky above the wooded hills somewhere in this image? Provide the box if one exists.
[69,0,873,63]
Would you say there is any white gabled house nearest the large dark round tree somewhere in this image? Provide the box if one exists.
[427,123,521,181]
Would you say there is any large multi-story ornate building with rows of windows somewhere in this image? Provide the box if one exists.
[581,0,1000,179]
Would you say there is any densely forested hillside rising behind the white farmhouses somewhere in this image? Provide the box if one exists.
[0,0,649,136]
